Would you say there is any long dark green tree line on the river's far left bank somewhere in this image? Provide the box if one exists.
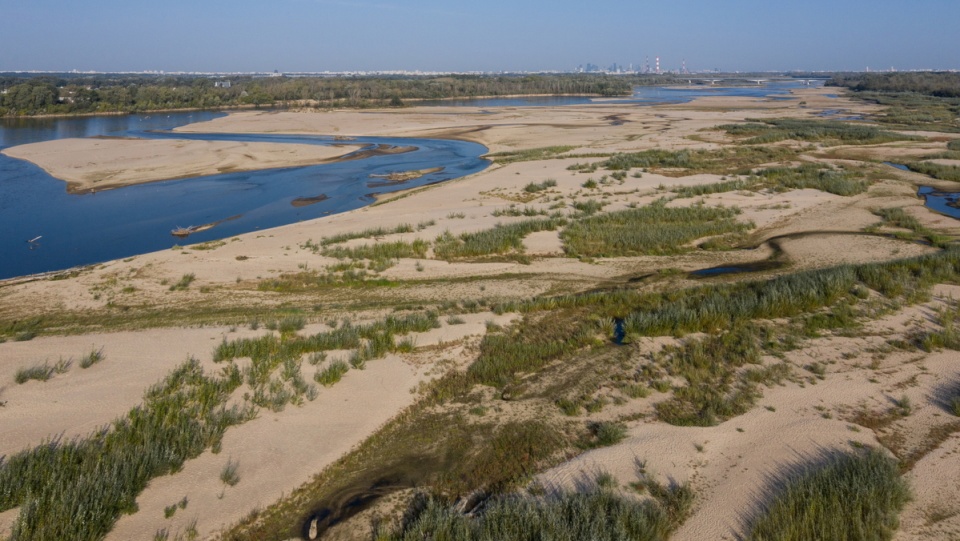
[0,74,676,116]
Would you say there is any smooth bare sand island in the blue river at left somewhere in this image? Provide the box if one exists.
[3,138,362,193]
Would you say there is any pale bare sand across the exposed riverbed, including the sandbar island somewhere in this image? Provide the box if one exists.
[0,85,960,541]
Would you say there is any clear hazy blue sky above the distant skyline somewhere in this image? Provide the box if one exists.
[0,0,960,71]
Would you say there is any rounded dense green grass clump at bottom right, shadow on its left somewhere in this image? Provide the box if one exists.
[747,450,910,541]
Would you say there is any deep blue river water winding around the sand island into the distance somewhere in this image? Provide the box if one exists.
[0,81,819,279]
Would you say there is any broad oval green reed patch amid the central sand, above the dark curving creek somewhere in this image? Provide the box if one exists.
[561,200,753,257]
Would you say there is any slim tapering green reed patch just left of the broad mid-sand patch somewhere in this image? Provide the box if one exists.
[433,217,566,261]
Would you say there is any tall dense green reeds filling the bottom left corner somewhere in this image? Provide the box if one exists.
[0,359,255,540]
